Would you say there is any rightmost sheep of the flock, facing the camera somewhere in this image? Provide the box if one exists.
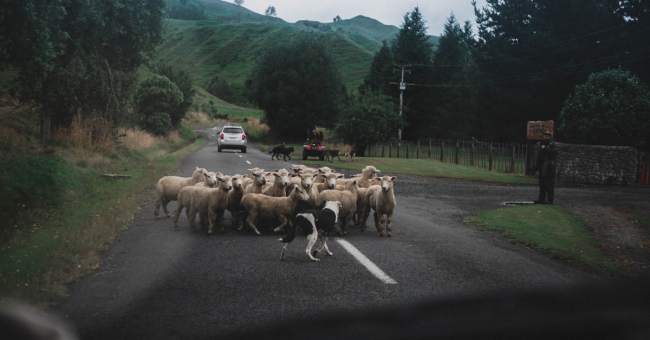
[361,176,397,237]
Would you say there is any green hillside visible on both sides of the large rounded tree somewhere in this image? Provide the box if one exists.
[151,20,374,103]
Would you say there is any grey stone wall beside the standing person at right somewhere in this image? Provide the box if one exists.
[556,143,639,185]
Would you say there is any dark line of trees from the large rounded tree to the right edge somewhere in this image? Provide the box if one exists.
[247,0,650,149]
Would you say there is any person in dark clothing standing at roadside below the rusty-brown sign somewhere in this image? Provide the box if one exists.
[534,130,558,204]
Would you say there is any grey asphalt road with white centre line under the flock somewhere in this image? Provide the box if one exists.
[51,123,628,339]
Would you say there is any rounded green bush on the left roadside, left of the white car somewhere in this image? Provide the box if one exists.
[134,74,183,136]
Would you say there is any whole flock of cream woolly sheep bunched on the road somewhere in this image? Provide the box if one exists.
[154,164,396,237]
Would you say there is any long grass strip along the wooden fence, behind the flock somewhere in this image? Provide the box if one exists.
[294,157,536,186]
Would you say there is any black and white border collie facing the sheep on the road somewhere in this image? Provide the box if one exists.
[280,201,342,261]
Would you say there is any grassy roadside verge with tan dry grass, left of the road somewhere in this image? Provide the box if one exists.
[0,128,205,307]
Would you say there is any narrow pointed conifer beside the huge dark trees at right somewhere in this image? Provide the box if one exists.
[431,14,480,139]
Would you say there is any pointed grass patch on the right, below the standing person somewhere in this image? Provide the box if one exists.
[465,205,623,275]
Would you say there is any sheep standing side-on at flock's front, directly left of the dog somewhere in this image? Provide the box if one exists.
[241,187,309,235]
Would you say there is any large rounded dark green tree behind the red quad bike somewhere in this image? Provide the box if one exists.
[247,32,343,139]
